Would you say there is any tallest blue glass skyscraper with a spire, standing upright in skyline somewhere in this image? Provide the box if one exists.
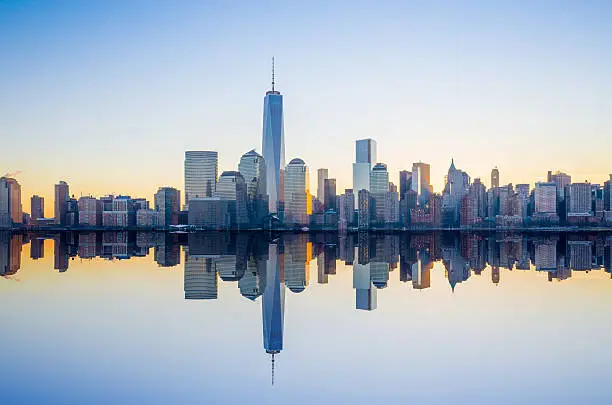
[262,58,285,212]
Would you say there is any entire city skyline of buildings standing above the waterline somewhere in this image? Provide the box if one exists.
[0,62,612,231]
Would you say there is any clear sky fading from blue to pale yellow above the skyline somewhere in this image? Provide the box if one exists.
[0,0,612,216]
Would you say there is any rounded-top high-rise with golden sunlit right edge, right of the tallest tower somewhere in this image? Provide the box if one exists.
[284,158,312,225]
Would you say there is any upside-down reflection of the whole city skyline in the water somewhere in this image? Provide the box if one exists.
[0,232,612,382]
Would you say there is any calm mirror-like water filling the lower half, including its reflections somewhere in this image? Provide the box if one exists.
[0,233,612,404]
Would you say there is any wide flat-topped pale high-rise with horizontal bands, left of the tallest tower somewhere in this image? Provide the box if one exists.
[185,151,219,210]
